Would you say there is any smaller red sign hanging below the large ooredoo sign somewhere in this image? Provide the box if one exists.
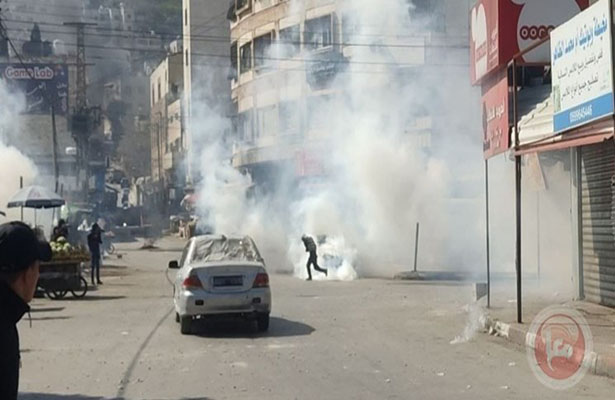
[482,68,510,159]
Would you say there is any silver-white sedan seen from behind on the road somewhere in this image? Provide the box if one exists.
[169,235,271,334]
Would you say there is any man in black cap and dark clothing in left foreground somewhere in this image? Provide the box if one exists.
[0,222,51,400]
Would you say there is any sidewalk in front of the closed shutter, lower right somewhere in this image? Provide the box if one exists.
[485,296,615,379]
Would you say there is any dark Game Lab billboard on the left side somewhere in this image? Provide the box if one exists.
[0,64,68,115]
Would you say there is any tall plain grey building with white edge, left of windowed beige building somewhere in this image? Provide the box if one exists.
[182,0,231,183]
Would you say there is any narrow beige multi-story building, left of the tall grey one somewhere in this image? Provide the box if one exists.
[150,48,186,211]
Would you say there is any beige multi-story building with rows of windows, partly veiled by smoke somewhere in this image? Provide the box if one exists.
[229,0,471,189]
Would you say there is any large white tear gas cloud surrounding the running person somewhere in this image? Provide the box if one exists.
[192,0,484,279]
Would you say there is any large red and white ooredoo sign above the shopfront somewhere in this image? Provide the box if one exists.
[470,0,589,84]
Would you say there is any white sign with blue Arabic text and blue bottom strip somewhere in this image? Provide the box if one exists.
[551,0,613,132]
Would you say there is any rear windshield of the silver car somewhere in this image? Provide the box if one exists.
[191,237,262,263]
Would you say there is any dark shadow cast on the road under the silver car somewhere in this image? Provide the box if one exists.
[193,317,315,338]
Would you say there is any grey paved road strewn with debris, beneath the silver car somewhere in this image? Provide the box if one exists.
[20,236,615,400]
